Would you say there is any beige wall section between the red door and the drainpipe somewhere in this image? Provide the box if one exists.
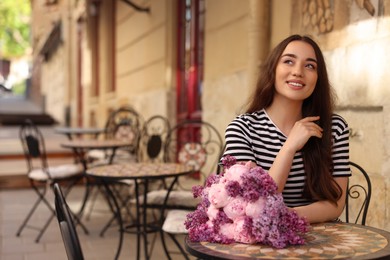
[202,0,249,133]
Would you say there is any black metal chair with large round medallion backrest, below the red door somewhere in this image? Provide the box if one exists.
[148,120,224,209]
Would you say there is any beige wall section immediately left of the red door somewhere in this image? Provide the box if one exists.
[112,0,175,123]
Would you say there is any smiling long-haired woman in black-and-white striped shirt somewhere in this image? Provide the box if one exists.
[225,35,351,223]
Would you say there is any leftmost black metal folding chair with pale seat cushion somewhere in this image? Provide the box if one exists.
[16,120,88,242]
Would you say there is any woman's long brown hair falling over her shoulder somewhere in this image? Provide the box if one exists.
[246,35,342,204]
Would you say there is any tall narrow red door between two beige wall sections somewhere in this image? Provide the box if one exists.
[177,0,205,123]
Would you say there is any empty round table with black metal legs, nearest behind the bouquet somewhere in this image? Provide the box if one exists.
[87,163,193,259]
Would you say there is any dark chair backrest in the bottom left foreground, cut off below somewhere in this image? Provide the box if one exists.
[53,183,84,260]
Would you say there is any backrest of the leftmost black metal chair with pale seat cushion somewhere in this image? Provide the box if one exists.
[19,119,50,174]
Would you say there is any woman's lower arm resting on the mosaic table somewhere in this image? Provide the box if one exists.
[293,177,348,223]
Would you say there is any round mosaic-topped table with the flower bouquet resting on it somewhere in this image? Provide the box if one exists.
[185,222,390,260]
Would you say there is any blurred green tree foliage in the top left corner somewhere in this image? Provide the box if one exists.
[0,0,31,58]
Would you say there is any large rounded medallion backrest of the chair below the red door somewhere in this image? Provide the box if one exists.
[165,120,224,181]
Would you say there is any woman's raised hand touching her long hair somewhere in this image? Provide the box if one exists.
[284,116,323,152]
